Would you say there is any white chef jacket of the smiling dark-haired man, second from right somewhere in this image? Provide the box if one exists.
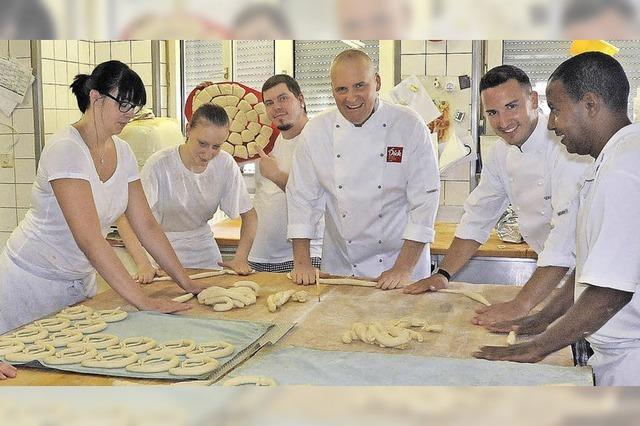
[456,111,592,268]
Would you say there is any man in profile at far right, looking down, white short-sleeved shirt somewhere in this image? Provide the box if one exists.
[474,52,640,386]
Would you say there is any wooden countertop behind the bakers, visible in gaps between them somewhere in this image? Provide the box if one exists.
[213,218,538,259]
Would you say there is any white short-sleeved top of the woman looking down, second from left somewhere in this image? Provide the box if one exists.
[140,146,252,269]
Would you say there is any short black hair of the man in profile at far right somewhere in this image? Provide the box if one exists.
[549,52,629,113]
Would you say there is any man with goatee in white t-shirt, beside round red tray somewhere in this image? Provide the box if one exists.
[249,74,324,272]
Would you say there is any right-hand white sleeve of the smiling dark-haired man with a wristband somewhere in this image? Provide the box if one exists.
[537,148,591,268]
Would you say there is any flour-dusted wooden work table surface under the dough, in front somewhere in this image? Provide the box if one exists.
[0,272,573,386]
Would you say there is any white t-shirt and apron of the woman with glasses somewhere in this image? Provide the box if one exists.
[0,126,139,333]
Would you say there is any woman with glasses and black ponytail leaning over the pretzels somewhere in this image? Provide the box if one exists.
[0,61,211,340]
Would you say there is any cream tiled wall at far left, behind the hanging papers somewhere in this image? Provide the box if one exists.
[0,40,36,249]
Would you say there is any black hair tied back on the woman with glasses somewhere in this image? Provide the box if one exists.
[69,61,147,113]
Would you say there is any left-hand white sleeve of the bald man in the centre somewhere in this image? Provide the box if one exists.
[286,131,326,239]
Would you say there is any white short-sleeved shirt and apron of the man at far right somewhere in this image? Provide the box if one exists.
[575,124,640,386]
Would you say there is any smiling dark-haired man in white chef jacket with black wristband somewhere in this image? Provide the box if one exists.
[405,65,591,325]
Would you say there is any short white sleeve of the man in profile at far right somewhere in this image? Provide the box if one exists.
[576,170,640,292]
